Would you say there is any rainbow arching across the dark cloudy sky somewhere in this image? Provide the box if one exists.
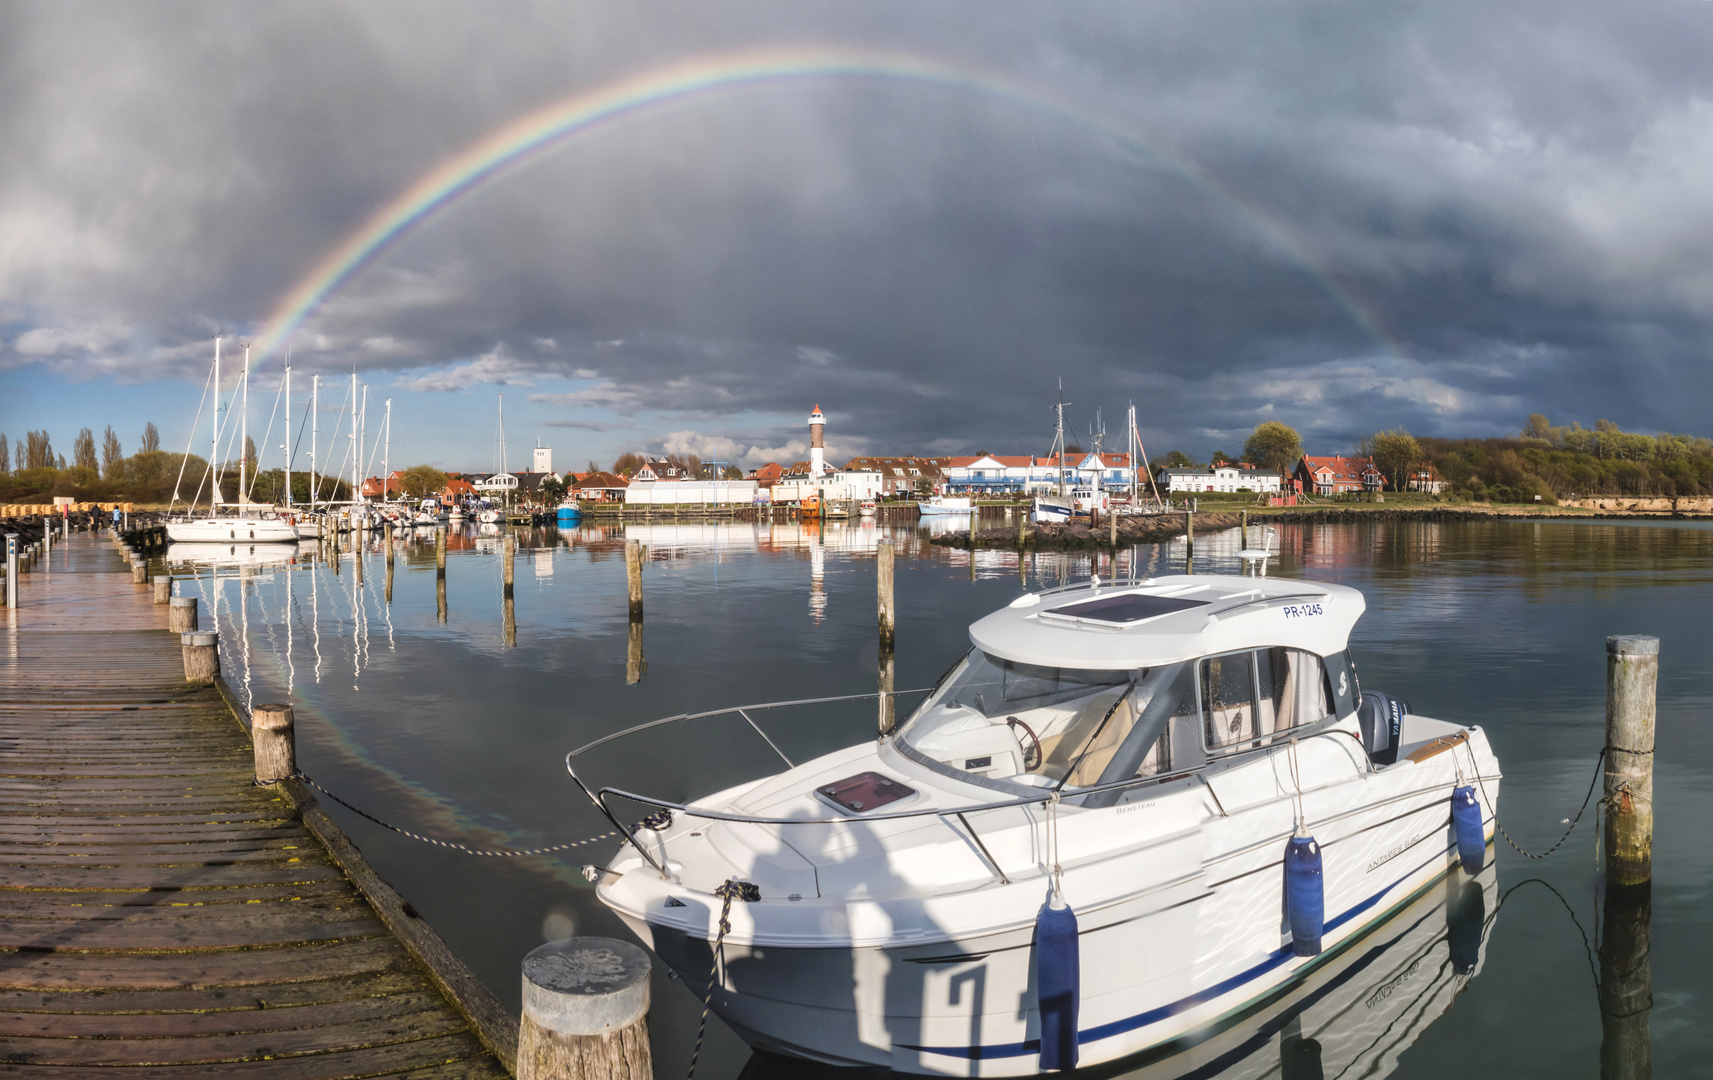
[255,46,1403,365]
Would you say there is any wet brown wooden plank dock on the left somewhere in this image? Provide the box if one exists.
[0,533,516,1080]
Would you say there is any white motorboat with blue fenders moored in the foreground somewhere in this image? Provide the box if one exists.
[567,576,1501,1077]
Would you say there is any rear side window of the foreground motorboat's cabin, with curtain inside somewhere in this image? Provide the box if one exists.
[1199,646,1334,751]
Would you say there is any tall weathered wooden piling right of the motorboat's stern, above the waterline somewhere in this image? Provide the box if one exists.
[1605,634,1660,886]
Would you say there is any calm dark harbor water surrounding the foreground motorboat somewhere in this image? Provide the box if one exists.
[175,521,1713,1078]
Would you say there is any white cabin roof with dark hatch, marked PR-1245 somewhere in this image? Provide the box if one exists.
[970,574,1367,670]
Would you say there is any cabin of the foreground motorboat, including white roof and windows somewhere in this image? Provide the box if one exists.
[894,576,1364,806]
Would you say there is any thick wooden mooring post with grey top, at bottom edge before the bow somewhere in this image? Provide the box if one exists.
[517,938,654,1080]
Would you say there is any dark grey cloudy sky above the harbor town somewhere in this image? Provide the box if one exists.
[0,0,1713,470]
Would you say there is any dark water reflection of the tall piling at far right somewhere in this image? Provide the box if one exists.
[1598,885,1653,1080]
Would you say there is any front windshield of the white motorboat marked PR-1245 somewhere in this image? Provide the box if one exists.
[898,650,1199,789]
